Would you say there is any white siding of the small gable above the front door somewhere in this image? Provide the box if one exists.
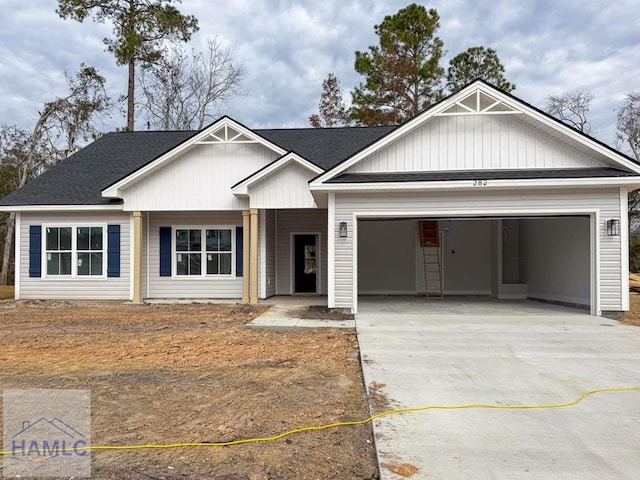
[249,162,317,208]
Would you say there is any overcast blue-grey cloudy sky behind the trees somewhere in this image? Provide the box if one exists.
[0,0,640,145]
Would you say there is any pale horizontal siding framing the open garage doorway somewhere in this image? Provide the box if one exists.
[332,188,626,311]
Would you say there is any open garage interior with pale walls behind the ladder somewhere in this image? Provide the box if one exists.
[357,215,594,308]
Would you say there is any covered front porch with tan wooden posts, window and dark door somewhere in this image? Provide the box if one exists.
[131,208,327,304]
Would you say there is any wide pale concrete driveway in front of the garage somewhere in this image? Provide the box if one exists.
[356,298,640,480]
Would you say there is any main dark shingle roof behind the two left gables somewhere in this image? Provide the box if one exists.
[0,127,394,206]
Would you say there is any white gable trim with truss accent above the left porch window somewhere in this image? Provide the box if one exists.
[102,116,286,198]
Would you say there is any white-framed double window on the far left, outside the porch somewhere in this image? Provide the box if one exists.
[44,226,106,277]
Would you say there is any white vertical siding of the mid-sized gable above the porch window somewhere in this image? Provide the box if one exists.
[123,143,278,212]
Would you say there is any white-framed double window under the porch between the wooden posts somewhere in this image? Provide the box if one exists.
[174,227,234,277]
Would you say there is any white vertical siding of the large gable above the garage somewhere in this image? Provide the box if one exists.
[347,115,611,173]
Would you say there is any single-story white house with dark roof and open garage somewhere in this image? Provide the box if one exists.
[0,80,640,315]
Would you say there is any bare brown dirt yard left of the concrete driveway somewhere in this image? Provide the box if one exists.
[0,301,377,480]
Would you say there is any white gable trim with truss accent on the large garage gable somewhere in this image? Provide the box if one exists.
[310,80,640,187]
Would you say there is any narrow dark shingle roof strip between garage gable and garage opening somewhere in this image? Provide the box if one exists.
[327,167,640,183]
